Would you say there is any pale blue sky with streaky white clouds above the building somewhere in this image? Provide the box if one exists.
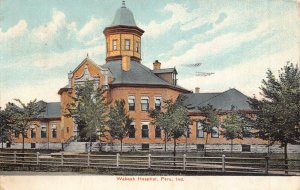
[0,0,300,106]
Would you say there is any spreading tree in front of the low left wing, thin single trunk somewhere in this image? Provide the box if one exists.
[6,99,45,152]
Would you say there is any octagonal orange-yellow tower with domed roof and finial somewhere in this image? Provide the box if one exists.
[103,1,144,65]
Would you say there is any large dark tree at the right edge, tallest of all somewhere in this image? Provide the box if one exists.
[250,62,300,172]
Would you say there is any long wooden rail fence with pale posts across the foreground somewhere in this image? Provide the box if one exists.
[0,152,300,175]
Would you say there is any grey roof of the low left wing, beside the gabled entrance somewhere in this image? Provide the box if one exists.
[37,100,61,119]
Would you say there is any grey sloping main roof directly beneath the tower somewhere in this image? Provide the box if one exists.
[102,60,189,92]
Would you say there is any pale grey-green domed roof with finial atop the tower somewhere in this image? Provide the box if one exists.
[111,2,136,26]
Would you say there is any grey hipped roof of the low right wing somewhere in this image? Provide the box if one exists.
[180,88,252,112]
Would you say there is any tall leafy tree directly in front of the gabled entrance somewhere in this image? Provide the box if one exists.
[67,80,107,151]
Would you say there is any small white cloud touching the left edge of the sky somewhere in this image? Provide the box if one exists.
[0,20,27,42]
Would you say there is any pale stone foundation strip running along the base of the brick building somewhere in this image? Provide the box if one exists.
[0,142,300,153]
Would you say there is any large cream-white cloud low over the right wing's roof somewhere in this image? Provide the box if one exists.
[179,48,299,96]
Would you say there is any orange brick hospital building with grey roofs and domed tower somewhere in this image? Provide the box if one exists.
[9,3,300,151]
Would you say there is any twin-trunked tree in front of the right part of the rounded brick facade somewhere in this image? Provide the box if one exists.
[149,100,190,158]
